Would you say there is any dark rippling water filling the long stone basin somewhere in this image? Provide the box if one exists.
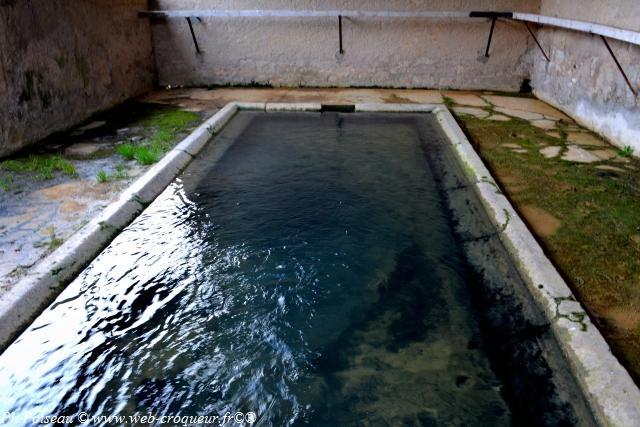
[0,113,510,426]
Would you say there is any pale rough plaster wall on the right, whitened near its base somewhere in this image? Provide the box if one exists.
[532,0,640,155]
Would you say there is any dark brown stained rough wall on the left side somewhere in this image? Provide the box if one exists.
[0,0,155,157]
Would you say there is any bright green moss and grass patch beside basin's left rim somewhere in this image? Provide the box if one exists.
[116,108,199,165]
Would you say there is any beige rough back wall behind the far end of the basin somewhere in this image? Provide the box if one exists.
[152,0,539,90]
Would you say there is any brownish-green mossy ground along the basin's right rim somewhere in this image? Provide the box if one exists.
[460,115,640,379]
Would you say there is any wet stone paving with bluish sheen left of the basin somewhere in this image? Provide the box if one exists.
[0,103,204,291]
